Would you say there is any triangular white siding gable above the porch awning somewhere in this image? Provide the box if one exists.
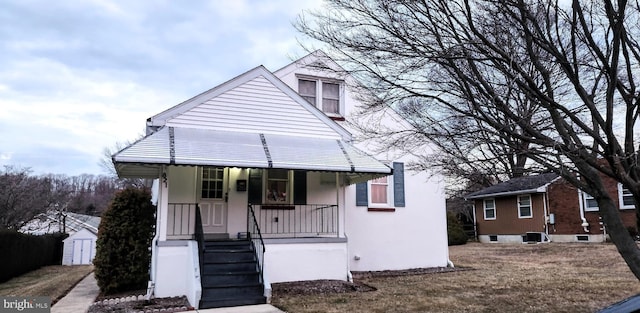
[166,76,340,138]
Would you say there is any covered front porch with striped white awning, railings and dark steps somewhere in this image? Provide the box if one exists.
[113,127,392,303]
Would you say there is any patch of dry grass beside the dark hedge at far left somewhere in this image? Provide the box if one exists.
[0,265,93,303]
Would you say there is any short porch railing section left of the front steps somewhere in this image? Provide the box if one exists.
[167,203,200,239]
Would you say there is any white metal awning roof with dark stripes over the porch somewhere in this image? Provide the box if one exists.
[113,126,392,183]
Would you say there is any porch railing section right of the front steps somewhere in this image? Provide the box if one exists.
[253,204,339,238]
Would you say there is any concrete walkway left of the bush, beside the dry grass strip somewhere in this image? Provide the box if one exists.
[51,273,100,313]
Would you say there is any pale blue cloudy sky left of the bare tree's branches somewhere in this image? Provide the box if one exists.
[0,0,322,175]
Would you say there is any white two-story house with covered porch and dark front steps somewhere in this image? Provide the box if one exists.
[113,51,448,308]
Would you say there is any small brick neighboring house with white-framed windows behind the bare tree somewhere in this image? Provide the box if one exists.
[466,173,637,243]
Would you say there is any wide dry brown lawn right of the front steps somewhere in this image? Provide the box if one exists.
[273,243,640,313]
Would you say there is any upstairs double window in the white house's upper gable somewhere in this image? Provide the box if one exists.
[298,78,343,116]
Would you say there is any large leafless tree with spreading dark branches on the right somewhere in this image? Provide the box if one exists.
[298,0,640,278]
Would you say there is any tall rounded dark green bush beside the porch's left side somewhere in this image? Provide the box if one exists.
[93,188,155,294]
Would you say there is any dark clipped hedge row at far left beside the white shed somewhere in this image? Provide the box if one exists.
[0,230,68,282]
